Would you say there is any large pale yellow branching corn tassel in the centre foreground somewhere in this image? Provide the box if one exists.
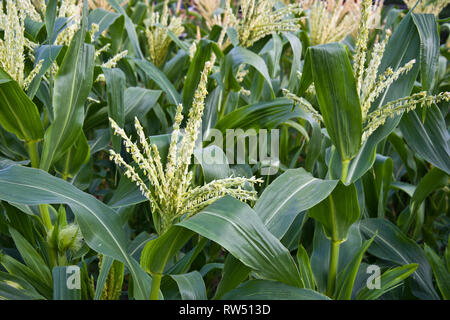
[110,55,263,234]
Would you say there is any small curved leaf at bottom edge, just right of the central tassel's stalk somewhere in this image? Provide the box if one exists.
[170,271,207,300]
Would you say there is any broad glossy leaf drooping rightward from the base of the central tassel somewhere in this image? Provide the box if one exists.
[178,196,302,287]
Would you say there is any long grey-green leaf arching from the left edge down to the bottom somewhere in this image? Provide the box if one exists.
[0,166,151,299]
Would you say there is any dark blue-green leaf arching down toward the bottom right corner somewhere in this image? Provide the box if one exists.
[360,219,439,300]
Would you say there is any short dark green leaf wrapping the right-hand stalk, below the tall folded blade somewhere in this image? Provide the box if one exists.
[308,183,360,242]
